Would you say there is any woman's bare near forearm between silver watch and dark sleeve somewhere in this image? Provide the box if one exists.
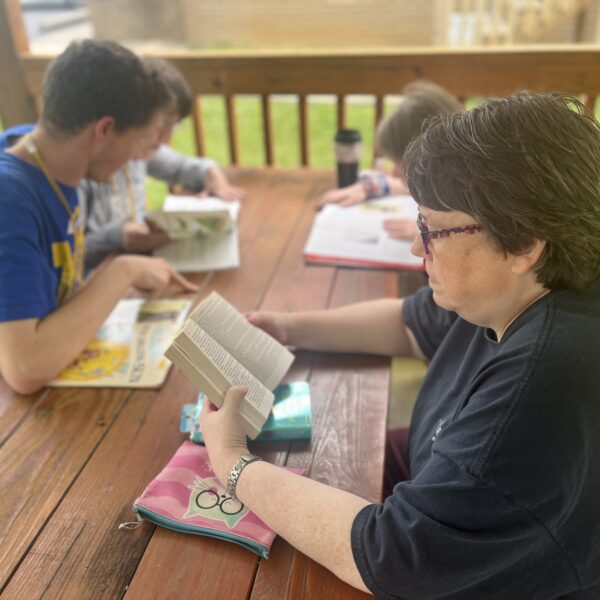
[236,461,370,591]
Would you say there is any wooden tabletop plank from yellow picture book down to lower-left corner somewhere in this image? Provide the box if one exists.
[0,389,131,589]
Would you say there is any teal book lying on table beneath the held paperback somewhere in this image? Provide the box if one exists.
[180,381,311,444]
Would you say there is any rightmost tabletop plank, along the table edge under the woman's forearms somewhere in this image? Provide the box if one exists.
[251,267,398,600]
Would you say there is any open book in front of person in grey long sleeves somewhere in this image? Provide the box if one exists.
[151,195,240,273]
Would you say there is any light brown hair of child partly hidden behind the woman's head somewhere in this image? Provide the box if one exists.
[376,81,463,164]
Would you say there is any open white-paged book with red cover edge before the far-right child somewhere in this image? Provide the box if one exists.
[304,196,423,271]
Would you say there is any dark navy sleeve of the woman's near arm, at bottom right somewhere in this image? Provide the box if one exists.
[351,453,579,600]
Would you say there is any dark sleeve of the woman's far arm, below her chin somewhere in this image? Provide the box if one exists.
[402,285,458,360]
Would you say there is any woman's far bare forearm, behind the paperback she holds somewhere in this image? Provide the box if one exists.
[287,298,420,356]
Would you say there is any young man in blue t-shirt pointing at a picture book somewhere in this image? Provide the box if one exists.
[0,40,195,393]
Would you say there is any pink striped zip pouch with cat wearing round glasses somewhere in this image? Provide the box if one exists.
[125,441,303,558]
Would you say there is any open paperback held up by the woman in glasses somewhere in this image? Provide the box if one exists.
[165,292,294,439]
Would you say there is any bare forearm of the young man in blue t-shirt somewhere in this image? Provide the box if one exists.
[0,261,136,394]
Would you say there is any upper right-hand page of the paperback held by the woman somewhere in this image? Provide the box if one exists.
[190,292,294,390]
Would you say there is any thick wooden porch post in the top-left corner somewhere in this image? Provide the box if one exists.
[0,0,38,127]
